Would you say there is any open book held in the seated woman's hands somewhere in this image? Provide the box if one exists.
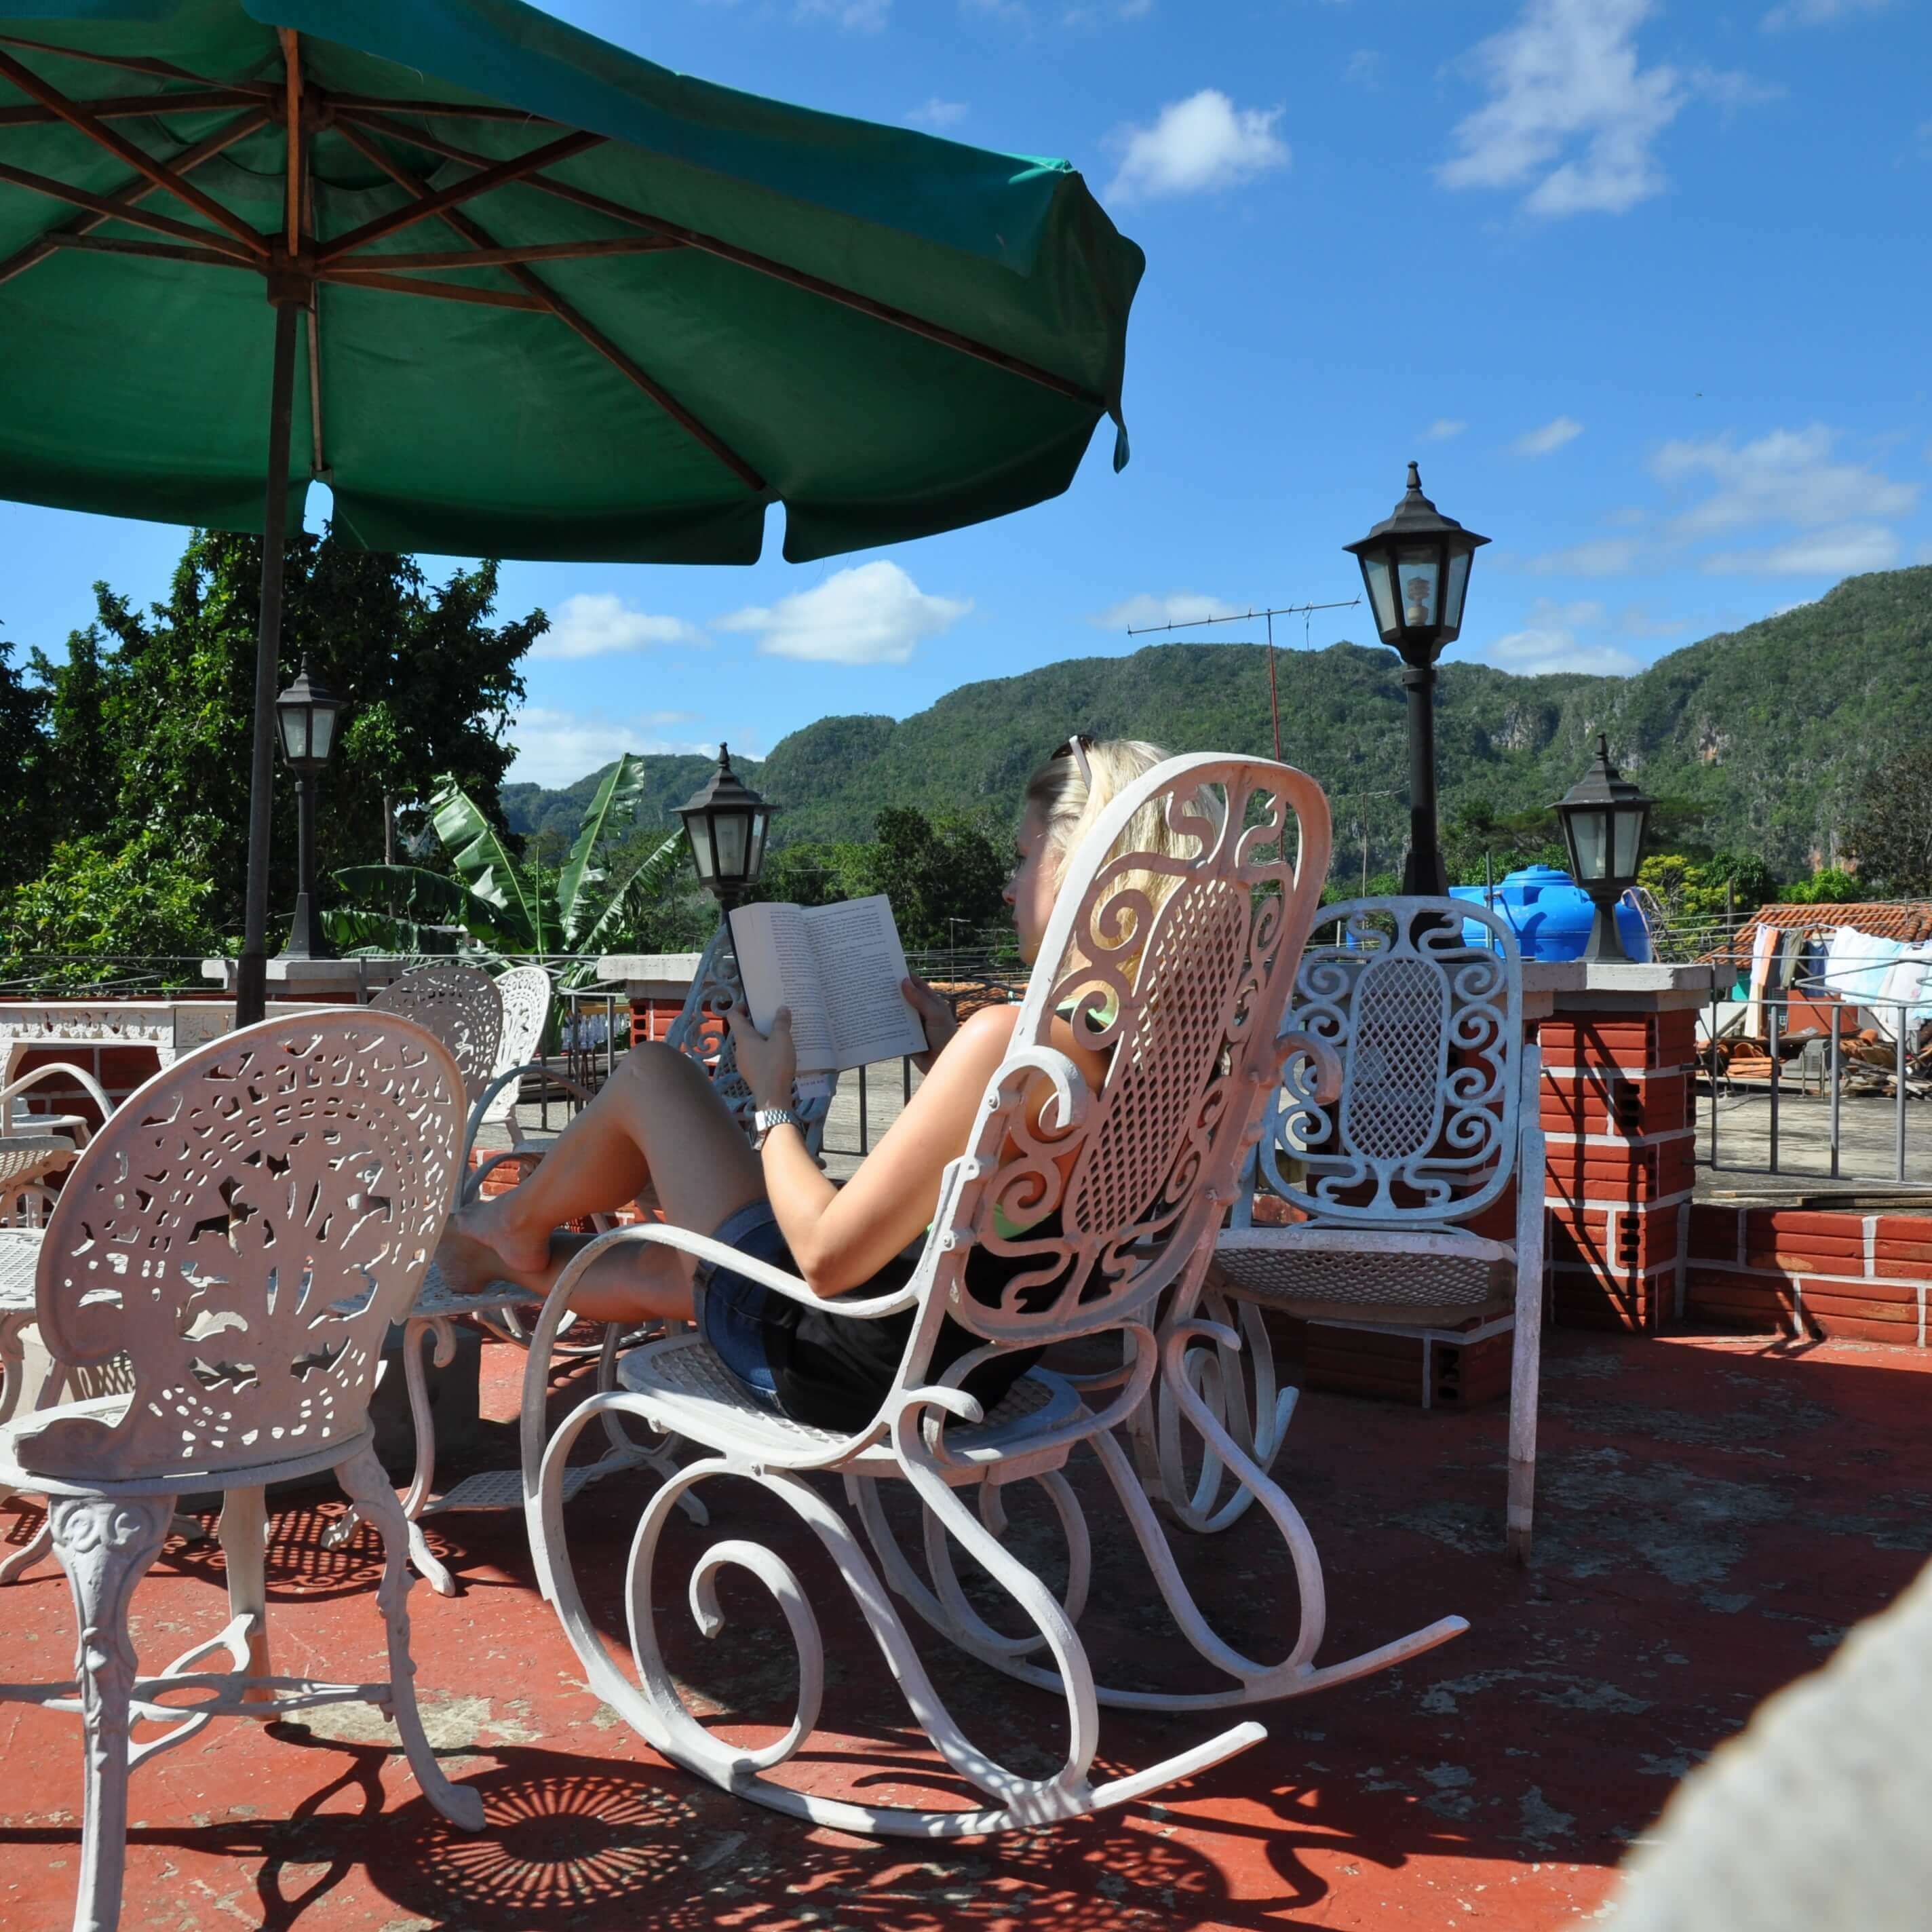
[731,893,925,1091]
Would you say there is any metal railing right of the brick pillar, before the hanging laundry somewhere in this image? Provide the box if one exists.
[1700,960,1932,1186]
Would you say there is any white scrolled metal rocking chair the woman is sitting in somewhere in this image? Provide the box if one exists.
[524,757,1467,1837]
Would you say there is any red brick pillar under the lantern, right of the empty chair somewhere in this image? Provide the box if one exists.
[1540,997,1697,1333]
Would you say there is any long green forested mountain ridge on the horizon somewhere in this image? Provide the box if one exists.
[502,568,1932,877]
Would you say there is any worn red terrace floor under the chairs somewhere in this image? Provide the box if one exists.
[0,1333,1932,1932]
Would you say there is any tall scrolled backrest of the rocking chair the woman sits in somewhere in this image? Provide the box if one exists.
[923,756,1329,1370]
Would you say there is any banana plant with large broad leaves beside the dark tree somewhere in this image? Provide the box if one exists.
[323,752,686,984]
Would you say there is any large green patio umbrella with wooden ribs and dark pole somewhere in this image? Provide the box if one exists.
[0,0,1142,1020]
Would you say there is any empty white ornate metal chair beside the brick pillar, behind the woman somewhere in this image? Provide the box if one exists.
[1205,898,1544,1563]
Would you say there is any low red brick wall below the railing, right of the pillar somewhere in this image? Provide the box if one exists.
[1684,1201,1932,1349]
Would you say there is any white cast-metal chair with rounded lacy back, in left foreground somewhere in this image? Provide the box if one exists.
[0,1011,483,1932]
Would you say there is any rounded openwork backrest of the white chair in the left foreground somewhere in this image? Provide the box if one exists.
[16,1009,464,1482]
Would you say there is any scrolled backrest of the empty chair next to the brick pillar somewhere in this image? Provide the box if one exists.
[1237,898,1524,1229]
